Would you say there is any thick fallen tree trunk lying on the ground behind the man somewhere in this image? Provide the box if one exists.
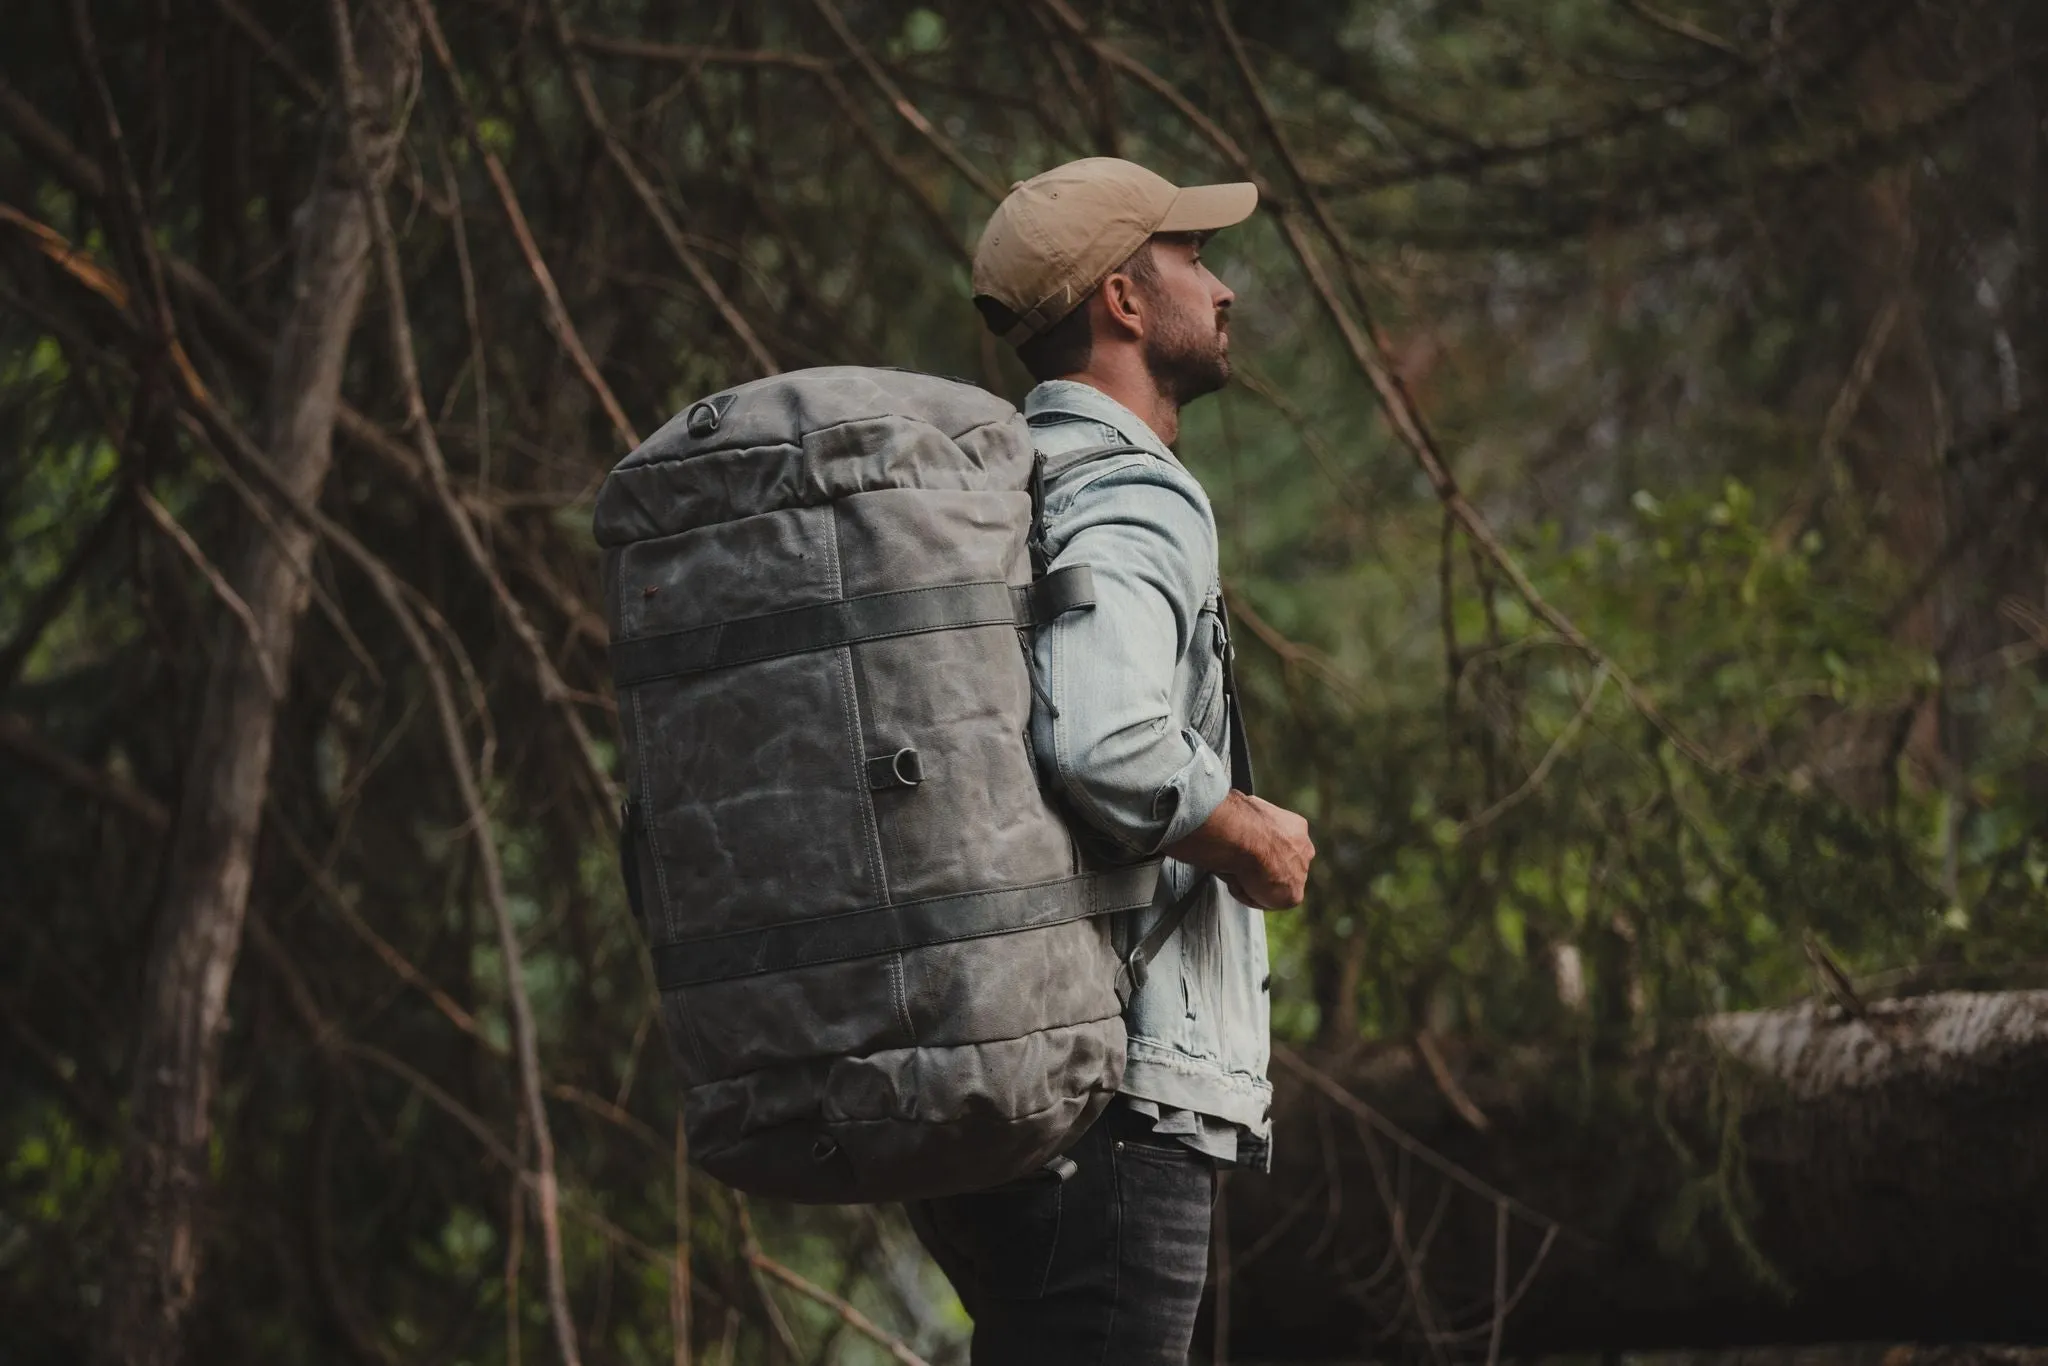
[1204,991,2048,1362]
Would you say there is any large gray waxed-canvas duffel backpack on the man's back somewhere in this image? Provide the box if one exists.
[596,367,1212,1202]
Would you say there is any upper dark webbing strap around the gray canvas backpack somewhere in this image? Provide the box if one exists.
[612,565,1096,688]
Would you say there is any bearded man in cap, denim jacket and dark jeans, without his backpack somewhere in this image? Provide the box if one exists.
[911,158,1315,1366]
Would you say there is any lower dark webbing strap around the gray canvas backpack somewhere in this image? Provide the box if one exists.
[653,862,1159,991]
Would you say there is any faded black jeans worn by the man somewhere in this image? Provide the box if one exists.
[909,1100,1217,1366]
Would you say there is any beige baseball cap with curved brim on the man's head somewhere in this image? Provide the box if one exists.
[975,156,1260,346]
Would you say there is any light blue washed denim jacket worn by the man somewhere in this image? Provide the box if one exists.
[1024,381,1272,1167]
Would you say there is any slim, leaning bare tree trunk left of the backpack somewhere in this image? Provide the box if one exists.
[98,10,418,1366]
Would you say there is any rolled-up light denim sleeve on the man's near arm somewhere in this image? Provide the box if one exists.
[1034,463,1231,854]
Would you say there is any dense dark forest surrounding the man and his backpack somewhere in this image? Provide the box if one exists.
[0,0,2048,1362]
